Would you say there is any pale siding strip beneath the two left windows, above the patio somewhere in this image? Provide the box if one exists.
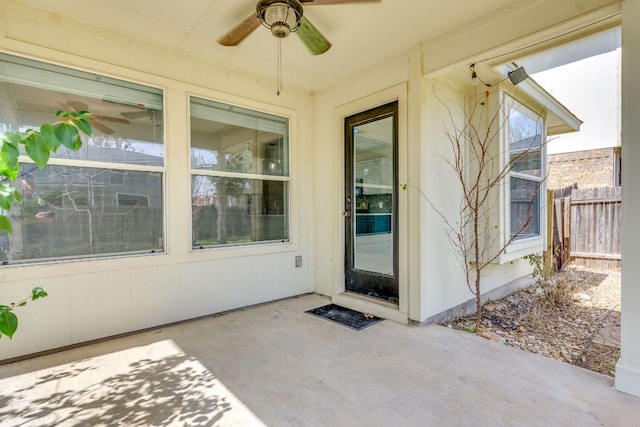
[0,253,313,359]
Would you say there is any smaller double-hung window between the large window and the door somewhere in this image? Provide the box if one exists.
[190,98,289,248]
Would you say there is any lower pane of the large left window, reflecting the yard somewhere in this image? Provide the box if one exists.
[0,164,162,262]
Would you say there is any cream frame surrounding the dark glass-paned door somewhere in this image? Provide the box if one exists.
[331,83,410,323]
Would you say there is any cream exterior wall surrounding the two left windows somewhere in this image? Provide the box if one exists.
[0,3,314,359]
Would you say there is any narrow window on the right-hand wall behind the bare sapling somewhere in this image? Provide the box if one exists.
[508,101,544,239]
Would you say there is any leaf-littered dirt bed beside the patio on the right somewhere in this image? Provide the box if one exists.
[451,267,620,376]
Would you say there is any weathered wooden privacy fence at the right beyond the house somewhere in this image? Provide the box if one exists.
[553,187,622,270]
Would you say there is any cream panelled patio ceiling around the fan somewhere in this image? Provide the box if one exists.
[12,0,514,92]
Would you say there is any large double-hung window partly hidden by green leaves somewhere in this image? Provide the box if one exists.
[0,54,164,264]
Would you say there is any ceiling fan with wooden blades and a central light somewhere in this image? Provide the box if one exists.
[218,0,381,55]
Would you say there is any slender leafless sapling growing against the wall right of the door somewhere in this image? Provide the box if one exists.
[403,88,546,332]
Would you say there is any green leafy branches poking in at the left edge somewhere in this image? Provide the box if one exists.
[0,111,92,338]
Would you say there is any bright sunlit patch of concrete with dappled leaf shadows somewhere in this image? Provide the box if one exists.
[0,343,231,426]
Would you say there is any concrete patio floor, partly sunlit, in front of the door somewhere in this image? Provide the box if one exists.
[0,295,640,426]
